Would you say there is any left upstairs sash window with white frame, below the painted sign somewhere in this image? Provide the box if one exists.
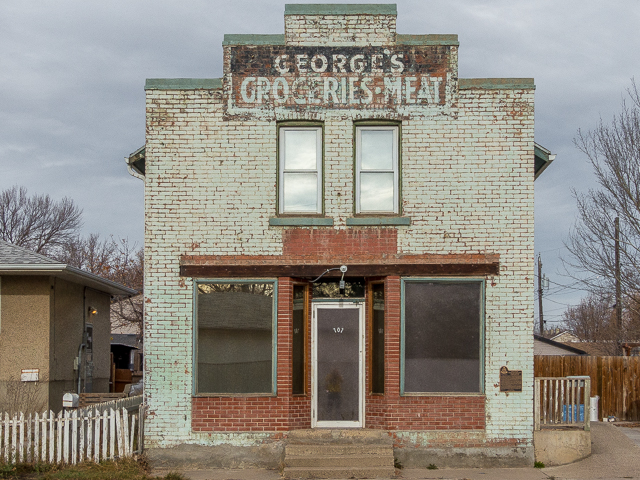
[278,127,322,214]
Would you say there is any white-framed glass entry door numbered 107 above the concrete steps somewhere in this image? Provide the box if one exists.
[311,301,364,428]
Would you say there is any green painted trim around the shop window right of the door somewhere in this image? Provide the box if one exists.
[400,277,487,397]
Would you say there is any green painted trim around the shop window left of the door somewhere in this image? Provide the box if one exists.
[191,278,278,397]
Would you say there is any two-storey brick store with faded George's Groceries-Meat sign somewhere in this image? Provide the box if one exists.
[128,5,554,466]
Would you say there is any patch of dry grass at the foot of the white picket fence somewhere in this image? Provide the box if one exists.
[0,459,186,480]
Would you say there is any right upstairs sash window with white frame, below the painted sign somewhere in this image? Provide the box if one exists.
[356,126,399,213]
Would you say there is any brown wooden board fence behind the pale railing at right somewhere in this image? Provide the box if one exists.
[534,355,640,421]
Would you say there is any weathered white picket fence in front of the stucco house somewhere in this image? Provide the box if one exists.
[0,399,144,464]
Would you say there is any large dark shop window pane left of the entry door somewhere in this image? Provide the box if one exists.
[195,281,276,394]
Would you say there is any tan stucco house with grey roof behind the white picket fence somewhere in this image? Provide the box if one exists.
[0,240,136,412]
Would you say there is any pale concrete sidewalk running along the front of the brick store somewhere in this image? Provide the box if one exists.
[153,422,640,480]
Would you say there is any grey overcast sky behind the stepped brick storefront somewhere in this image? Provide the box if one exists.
[0,0,640,321]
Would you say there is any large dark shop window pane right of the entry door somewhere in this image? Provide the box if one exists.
[403,279,483,393]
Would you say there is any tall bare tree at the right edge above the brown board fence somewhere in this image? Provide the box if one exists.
[565,82,640,338]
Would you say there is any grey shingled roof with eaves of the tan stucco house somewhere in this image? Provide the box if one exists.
[0,240,138,295]
